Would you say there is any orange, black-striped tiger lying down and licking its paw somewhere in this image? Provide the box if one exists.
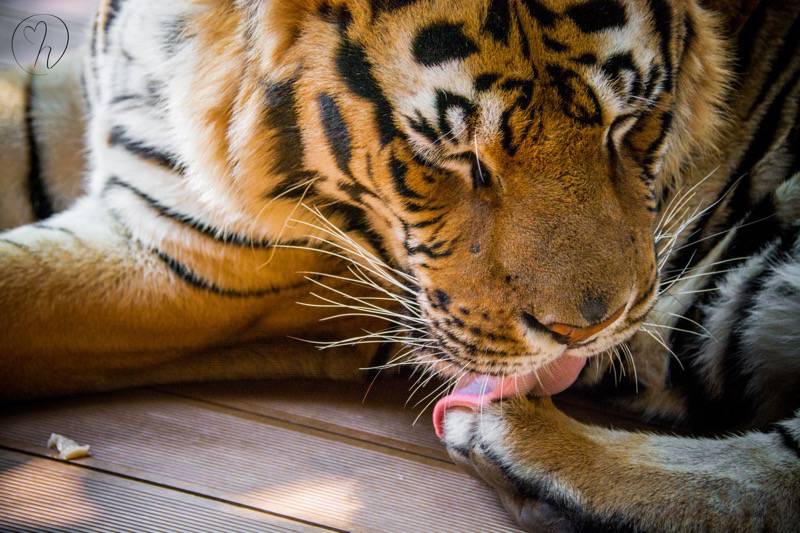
[0,0,800,531]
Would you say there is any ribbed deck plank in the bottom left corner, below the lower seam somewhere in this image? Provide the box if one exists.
[0,450,324,532]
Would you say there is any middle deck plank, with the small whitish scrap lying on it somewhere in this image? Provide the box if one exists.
[0,391,516,532]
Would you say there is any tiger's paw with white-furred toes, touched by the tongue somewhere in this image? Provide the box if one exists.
[442,399,576,532]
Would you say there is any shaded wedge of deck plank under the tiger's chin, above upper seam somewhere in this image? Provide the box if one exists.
[163,377,449,460]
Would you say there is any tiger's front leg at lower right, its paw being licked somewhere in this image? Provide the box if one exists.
[444,399,800,531]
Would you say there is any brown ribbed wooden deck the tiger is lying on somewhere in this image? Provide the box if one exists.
[0,377,664,532]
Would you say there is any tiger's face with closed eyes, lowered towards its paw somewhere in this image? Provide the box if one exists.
[262,0,721,388]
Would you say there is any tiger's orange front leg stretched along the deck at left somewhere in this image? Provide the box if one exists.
[0,197,376,400]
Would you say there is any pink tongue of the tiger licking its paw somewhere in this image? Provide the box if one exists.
[433,355,586,438]
